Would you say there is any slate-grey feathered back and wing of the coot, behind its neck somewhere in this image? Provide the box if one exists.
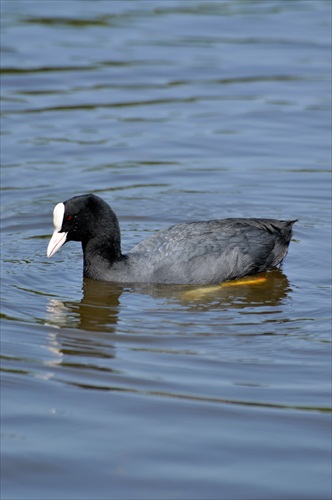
[129,219,294,283]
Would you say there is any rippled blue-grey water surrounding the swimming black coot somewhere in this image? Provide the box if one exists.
[1,0,331,500]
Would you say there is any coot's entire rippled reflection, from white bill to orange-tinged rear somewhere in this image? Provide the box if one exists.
[47,269,290,371]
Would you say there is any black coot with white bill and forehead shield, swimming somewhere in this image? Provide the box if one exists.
[47,194,296,284]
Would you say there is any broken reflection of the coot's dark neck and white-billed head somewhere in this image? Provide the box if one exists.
[46,280,124,374]
